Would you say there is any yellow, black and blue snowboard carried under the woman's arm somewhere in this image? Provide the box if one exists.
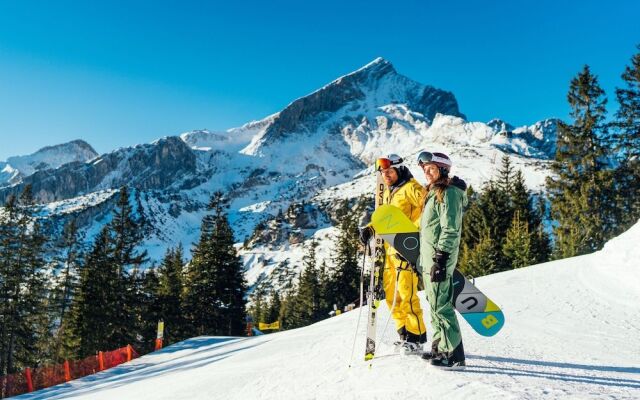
[371,205,504,336]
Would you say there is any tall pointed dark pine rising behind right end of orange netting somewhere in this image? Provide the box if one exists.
[67,187,147,356]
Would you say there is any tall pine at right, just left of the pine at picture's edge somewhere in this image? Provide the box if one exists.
[547,66,613,258]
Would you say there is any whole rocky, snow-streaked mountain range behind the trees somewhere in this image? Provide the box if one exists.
[0,58,557,292]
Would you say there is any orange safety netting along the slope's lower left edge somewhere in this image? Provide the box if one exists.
[0,346,140,399]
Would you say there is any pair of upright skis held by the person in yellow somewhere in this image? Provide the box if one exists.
[364,170,385,361]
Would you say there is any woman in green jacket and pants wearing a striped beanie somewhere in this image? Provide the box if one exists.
[418,151,467,367]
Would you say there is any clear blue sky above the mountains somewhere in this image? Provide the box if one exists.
[0,0,640,160]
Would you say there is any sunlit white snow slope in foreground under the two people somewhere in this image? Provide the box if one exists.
[16,223,640,400]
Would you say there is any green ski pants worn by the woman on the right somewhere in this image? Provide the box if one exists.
[424,271,462,353]
